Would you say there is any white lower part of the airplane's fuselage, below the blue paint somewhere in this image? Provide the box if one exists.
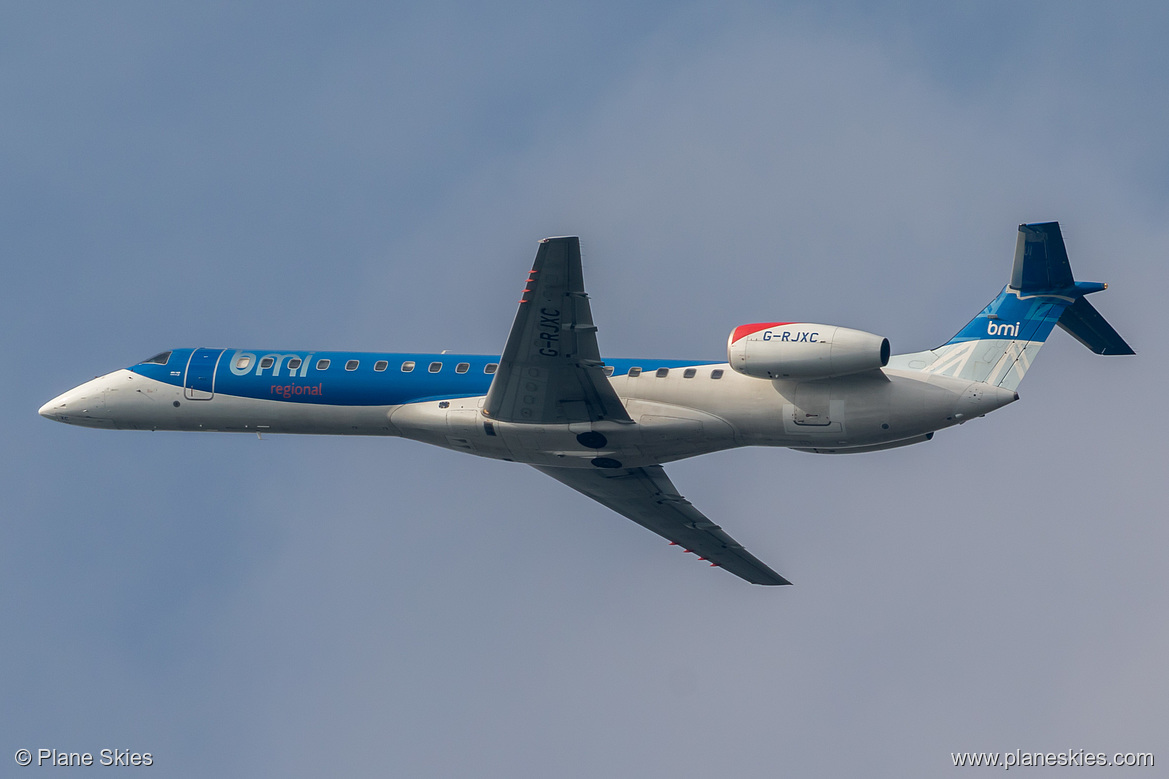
[41,364,1017,467]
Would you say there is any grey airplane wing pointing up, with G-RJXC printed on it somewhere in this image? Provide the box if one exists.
[484,237,632,425]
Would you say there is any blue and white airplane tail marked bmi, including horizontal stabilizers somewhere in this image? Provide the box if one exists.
[890,222,1134,390]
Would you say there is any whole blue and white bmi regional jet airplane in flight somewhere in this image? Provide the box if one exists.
[40,222,1134,585]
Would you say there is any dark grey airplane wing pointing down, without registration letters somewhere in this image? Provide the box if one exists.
[533,466,791,585]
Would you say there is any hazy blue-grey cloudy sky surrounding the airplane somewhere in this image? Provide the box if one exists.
[0,1,1169,778]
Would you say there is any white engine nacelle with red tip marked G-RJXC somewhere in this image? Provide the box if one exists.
[727,322,888,379]
